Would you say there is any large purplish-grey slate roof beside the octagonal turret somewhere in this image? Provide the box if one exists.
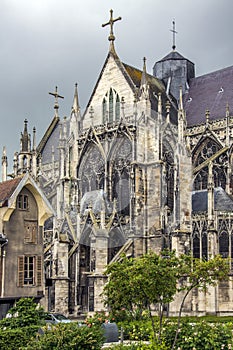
[184,66,233,126]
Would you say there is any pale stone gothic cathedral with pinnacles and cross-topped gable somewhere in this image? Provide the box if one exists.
[3,11,233,315]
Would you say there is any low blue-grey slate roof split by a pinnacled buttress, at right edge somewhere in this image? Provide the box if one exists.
[192,187,233,213]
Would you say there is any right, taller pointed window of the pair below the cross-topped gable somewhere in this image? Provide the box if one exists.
[110,137,132,215]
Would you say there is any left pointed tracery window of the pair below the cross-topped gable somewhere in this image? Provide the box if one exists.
[78,143,105,196]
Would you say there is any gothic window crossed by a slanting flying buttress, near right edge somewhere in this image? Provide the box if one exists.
[193,137,227,191]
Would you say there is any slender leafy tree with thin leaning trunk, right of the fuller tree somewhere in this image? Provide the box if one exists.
[172,255,229,349]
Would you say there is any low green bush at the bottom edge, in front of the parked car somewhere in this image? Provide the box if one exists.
[22,322,104,350]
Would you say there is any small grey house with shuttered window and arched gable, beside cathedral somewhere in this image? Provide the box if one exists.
[0,174,54,318]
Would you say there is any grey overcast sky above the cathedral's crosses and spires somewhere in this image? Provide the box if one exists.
[0,0,233,172]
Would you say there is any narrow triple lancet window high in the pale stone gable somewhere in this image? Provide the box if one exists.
[102,88,120,123]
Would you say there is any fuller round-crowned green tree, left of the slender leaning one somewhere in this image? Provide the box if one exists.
[104,250,183,340]
